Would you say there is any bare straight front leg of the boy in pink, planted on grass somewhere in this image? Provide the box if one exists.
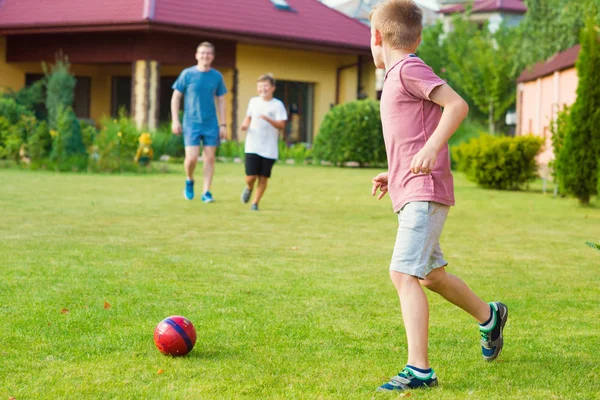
[390,271,429,369]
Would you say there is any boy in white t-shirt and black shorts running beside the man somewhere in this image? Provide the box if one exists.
[241,74,287,211]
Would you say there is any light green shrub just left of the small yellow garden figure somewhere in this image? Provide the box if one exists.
[91,111,139,172]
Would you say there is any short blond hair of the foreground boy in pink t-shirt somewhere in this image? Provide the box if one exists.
[369,0,423,50]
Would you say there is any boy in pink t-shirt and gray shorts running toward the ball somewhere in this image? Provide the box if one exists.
[371,0,508,391]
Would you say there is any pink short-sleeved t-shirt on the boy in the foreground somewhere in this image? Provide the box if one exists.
[381,54,454,216]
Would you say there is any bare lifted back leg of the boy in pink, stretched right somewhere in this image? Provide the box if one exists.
[421,267,490,324]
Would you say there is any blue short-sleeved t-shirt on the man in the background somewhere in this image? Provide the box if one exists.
[173,66,227,125]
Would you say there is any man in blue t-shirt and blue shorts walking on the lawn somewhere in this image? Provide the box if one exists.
[171,42,227,203]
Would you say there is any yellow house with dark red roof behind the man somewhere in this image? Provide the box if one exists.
[0,0,376,143]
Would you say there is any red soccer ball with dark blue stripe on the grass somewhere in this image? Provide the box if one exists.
[154,315,196,357]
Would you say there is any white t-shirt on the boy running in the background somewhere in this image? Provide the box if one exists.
[245,96,287,160]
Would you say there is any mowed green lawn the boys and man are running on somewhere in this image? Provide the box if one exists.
[0,164,600,400]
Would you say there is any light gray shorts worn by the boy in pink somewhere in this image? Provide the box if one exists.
[390,201,450,279]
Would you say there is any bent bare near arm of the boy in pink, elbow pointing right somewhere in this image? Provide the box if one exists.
[410,84,469,174]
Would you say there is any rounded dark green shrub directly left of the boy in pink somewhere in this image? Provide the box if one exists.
[314,100,386,166]
